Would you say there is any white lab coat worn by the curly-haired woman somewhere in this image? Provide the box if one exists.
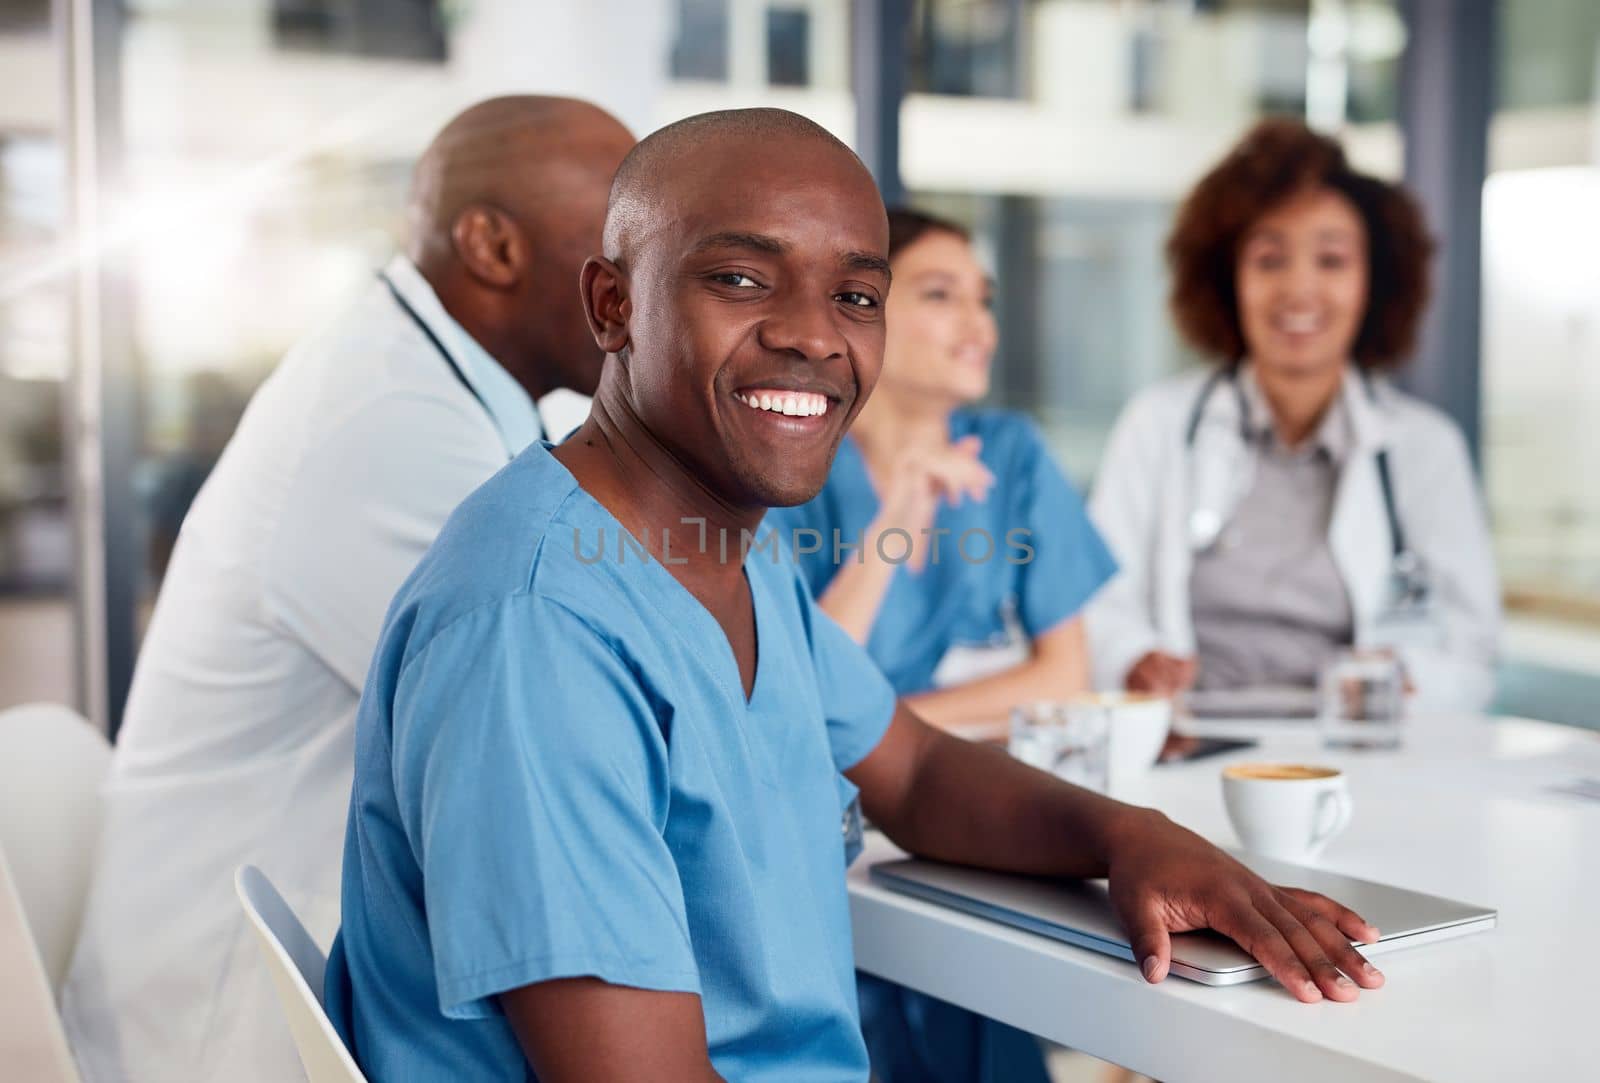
[1085,371,1501,710]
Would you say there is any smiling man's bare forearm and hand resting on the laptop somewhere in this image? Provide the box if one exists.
[846,702,1384,1001]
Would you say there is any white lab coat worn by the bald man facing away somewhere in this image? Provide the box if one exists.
[62,259,553,1083]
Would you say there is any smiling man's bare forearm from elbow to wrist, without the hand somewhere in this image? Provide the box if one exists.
[867,716,1160,877]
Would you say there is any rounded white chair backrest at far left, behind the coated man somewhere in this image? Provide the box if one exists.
[0,704,110,992]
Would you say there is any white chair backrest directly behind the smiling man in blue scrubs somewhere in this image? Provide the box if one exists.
[234,865,366,1083]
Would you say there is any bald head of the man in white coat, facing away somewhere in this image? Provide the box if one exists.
[408,94,634,395]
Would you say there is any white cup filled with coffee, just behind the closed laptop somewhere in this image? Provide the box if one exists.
[1222,763,1350,861]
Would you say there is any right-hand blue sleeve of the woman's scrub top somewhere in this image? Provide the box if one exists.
[1002,424,1117,638]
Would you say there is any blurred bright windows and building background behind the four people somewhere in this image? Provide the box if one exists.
[0,0,1600,735]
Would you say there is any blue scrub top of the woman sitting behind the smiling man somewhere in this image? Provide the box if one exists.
[766,410,1117,696]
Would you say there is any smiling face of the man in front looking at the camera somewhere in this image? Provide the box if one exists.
[608,134,890,507]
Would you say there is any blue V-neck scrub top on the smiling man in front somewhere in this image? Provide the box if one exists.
[326,445,894,1080]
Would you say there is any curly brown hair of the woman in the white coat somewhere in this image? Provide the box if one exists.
[1166,118,1434,368]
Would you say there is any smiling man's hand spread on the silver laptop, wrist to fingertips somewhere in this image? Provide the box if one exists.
[1109,809,1384,1003]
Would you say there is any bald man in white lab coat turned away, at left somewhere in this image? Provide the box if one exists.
[62,98,634,1083]
